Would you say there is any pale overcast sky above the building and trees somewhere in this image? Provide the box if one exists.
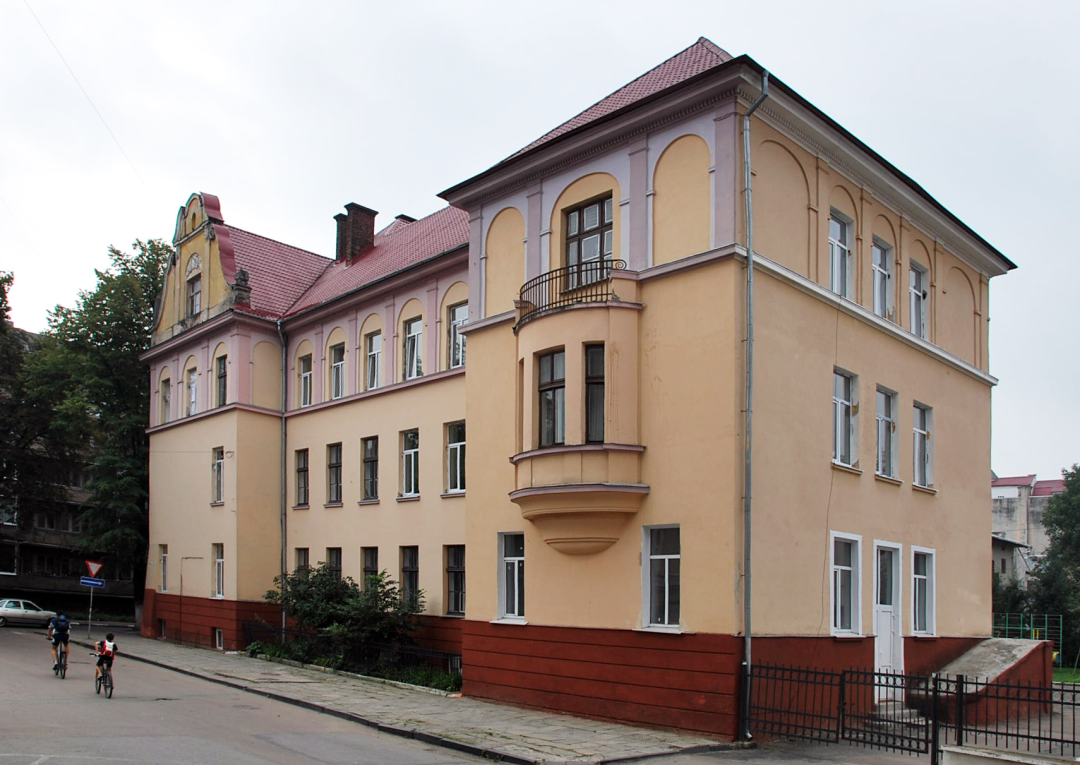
[0,0,1080,478]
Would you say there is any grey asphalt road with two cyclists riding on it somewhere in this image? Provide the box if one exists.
[0,627,482,765]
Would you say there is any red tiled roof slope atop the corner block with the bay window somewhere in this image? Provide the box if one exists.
[500,37,732,164]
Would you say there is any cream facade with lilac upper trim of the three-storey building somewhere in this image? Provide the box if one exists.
[141,43,1013,730]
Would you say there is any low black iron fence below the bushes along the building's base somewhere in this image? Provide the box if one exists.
[243,621,461,685]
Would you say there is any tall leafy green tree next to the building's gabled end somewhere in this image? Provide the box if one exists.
[26,239,173,612]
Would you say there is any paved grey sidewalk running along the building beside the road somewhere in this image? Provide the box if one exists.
[65,625,731,764]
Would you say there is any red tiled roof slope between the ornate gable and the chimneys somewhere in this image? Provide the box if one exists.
[220,224,334,319]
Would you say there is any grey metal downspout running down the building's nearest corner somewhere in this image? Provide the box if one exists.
[739,71,769,741]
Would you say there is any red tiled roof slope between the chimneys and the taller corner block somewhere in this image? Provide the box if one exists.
[285,207,469,316]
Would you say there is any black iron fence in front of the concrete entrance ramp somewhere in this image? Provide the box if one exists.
[750,665,1080,762]
